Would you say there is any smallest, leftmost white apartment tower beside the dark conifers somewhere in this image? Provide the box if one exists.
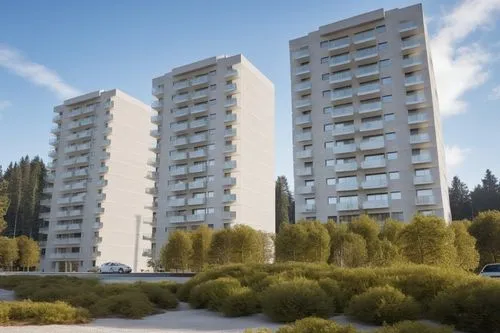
[40,90,153,272]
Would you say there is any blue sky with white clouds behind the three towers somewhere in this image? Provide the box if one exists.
[0,0,500,186]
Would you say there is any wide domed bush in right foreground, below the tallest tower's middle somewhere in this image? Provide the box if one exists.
[346,286,420,325]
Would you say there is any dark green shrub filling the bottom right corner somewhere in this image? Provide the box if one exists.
[430,279,500,333]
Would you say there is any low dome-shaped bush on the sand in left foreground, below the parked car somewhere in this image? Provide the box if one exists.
[90,291,155,319]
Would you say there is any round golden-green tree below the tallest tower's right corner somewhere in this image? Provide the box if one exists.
[400,215,456,266]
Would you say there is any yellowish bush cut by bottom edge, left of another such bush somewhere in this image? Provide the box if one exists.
[276,317,356,333]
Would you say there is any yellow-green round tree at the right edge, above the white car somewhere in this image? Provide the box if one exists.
[469,211,500,265]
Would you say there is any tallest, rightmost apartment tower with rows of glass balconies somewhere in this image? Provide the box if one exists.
[290,5,451,222]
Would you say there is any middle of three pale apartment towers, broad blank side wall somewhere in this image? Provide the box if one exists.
[148,55,274,256]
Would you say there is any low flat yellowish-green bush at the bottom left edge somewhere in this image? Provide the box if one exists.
[0,301,89,325]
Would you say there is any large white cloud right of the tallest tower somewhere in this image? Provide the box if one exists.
[431,0,500,116]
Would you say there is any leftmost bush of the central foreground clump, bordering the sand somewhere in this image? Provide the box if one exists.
[189,278,241,311]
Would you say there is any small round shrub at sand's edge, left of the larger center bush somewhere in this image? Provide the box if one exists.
[221,287,260,317]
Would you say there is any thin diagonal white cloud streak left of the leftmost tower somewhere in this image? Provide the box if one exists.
[0,44,80,99]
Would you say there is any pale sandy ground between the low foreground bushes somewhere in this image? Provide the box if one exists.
[0,289,461,333]
